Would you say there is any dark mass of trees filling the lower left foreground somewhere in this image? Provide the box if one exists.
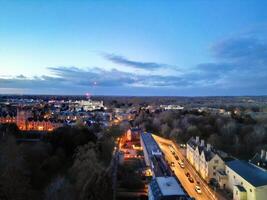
[0,125,114,200]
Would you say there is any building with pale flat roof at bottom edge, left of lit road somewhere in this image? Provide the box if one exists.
[148,177,188,200]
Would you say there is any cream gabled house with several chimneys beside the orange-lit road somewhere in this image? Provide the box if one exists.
[186,136,225,183]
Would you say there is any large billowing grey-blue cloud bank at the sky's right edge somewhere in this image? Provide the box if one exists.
[186,31,267,95]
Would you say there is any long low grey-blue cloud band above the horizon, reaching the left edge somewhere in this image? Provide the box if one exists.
[0,67,185,94]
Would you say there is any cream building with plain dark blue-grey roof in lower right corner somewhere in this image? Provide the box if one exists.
[226,160,267,200]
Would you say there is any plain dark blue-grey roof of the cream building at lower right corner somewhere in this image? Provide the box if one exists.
[226,160,267,187]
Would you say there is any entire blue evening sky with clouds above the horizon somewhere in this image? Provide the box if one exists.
[0,0,267,96]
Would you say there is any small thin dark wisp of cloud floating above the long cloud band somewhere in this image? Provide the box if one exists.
[103,54,170,70]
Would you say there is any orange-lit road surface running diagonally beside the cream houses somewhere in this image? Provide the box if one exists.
[153,135,228,200]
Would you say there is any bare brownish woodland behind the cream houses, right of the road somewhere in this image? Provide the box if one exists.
[133,110,267,159]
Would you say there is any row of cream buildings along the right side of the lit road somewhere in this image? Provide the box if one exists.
[186,137,267,200]
